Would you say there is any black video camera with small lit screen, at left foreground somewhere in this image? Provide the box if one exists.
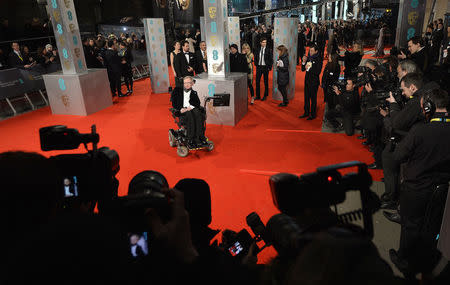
[39,125,120,209]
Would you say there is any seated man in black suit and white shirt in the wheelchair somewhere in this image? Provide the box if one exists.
[170,76,208,149]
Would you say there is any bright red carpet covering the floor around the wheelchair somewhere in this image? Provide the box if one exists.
[0,60,382,262]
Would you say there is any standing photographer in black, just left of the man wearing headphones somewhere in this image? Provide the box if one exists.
[380,73,424,210]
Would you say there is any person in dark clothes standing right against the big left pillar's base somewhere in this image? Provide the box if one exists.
[103,40,126,97]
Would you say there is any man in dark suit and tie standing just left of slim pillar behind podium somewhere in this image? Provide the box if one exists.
[255,38,273,101]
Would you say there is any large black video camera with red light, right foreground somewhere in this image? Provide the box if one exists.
[269,161,380,238]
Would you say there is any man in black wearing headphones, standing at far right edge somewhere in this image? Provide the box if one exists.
[389,89,450,275]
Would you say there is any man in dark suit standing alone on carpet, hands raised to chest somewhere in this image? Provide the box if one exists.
[299,44,322,120]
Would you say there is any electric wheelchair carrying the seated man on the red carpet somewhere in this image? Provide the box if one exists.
[169,99,214,157]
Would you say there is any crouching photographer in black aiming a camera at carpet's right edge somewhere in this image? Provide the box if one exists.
[326,78,360,136]
